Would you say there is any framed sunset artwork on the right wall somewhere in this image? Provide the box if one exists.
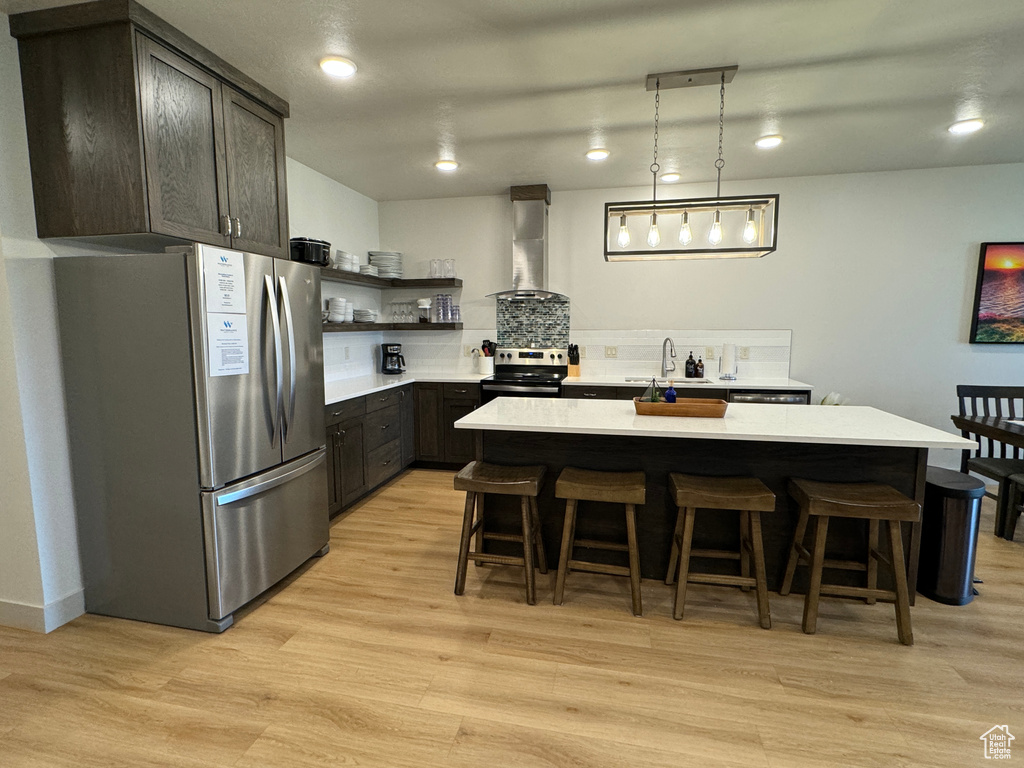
[971,243,1024,344]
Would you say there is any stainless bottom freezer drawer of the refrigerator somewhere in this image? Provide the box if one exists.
[202,449,330,620]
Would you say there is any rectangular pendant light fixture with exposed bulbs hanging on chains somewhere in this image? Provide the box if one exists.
[604,67,778,261]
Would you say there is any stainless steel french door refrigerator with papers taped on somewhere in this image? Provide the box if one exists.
[54,245,329,632]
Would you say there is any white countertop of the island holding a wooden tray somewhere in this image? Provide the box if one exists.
[455,397,975,449]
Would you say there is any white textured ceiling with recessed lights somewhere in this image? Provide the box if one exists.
[6,0,1024,200]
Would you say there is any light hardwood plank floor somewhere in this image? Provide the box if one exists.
[0,470,1024,768]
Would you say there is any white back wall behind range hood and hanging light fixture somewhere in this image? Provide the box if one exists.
[380,165,1024,464]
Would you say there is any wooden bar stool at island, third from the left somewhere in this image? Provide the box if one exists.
[665,472,775,630]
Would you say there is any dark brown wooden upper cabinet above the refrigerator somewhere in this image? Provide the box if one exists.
[10,0,288,258]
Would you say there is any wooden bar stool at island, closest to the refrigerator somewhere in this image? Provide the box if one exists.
[455,462,548,605]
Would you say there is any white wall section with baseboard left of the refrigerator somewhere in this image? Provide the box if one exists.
[0,14,84,631]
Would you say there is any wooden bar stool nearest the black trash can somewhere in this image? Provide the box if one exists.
[778,478,921,645]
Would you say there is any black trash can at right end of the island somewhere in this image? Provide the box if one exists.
[918,467,985,605]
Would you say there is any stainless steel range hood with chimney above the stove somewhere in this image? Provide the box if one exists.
[487,184,568,301]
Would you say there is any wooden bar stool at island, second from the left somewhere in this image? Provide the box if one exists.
[554,467,646,616]
